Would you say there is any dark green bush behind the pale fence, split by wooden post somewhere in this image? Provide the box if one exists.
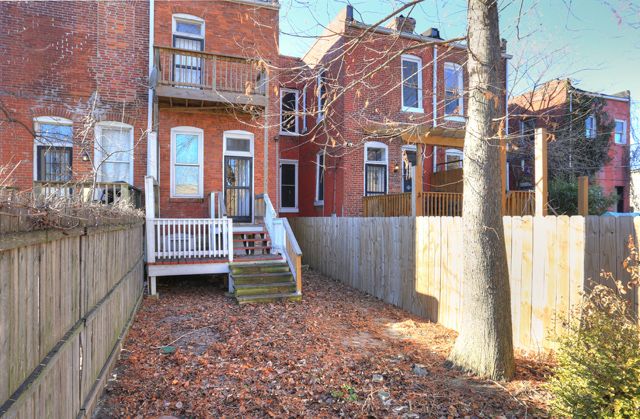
[549,178,618,215]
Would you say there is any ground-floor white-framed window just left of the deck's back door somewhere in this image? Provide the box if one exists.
[171,127,204,198]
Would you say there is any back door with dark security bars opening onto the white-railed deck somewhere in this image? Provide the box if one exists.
[224,156,253,223]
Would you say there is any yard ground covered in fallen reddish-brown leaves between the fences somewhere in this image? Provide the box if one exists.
[95,271,548,417]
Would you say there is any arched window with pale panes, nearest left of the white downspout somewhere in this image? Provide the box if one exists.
[93,122,133,184]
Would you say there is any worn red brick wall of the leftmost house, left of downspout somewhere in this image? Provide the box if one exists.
[0,1,149,189]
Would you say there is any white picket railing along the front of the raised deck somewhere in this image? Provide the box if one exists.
[147,218,233,261]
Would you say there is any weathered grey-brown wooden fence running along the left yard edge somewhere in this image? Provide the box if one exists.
[0,219,144,418]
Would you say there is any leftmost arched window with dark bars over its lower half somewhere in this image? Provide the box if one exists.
[33,116,73,182]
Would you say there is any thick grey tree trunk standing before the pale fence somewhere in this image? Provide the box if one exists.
[449,0,514,380]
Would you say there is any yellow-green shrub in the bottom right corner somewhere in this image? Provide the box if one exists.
[548,285,640,418]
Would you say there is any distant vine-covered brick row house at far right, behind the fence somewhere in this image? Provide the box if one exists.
[508,79,631,212]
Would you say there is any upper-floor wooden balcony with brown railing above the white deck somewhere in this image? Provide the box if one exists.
[151,47,267,107]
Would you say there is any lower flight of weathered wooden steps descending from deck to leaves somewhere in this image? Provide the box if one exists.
[229,259,302,304]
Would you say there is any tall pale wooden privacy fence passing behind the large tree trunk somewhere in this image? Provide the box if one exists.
[291,216,640,349]
